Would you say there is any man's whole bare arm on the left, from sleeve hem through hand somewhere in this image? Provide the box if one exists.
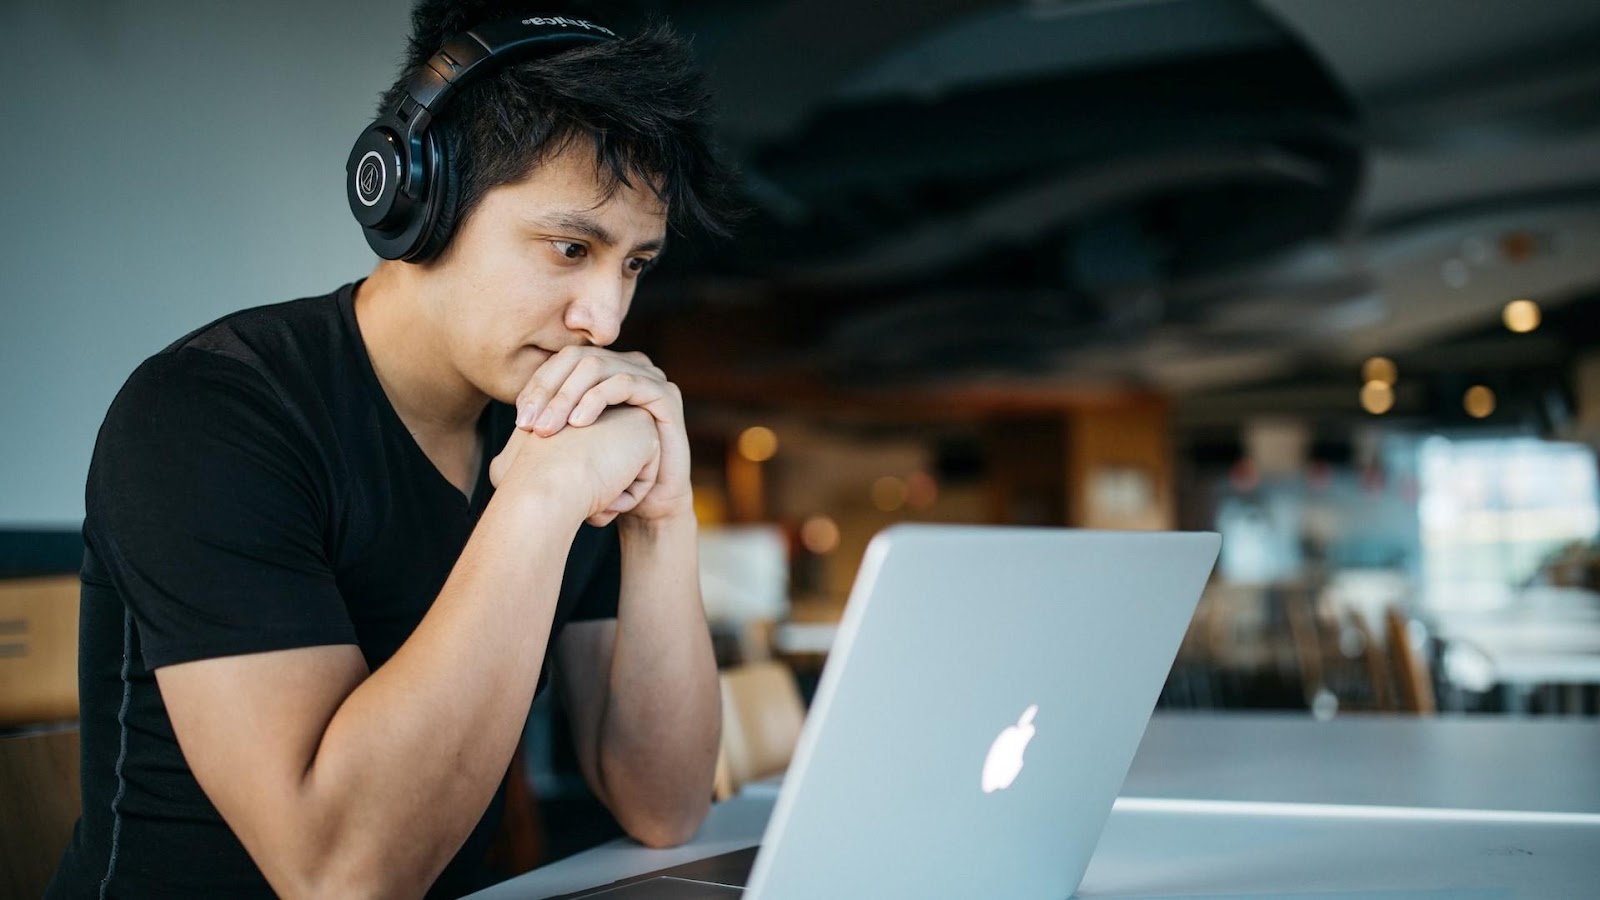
[155,408,656,897]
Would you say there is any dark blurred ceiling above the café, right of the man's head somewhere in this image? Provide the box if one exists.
[601,0,1600,421]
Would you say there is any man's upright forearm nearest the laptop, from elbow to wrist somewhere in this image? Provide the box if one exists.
[600,516,722,846]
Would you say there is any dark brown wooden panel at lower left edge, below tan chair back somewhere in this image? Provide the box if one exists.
[0,727,83,897]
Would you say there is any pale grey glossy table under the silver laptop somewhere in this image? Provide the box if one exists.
[474,713,1600,900]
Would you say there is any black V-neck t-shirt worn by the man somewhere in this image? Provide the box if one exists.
[48,285,621,898]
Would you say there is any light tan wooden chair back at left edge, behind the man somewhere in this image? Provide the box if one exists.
[0,575,78,729]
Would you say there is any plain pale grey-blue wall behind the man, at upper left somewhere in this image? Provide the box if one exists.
[0,0,410,528]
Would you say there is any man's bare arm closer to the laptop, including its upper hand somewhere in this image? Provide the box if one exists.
[518,348,722,847]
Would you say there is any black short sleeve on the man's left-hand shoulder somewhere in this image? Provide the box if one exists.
[83,349,355,669]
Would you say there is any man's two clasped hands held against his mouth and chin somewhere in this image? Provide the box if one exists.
[490,346,693,525]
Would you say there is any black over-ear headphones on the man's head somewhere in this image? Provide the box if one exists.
[344,16,618,263]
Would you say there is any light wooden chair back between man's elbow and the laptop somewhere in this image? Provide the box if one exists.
[715,661,805,799]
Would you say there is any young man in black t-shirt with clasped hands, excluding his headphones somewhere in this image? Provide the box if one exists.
[50,0,725,897]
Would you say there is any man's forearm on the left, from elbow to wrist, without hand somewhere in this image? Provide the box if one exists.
[299,495,576,894]
